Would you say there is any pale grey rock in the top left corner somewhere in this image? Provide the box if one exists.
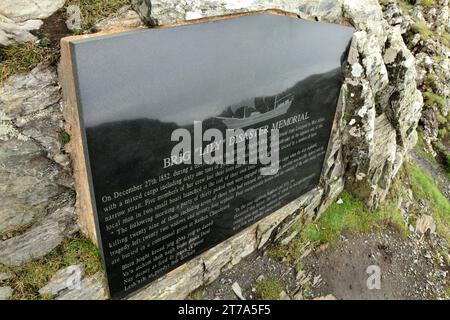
[0,0,65,22]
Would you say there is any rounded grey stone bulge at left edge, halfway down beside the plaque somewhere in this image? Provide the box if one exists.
[0,139,71,232]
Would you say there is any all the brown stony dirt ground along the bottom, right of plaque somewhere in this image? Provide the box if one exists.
[197,229,450,300]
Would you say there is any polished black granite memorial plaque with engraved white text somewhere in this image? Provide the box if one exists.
[70,14,353,298]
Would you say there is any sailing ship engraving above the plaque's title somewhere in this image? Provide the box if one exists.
[216,94,294,129]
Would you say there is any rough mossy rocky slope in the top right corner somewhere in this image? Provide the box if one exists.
[383,0,450,156]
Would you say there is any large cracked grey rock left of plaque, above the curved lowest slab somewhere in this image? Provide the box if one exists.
[0,65,73,233]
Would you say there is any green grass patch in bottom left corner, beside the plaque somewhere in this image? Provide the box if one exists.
[0,235,101,300]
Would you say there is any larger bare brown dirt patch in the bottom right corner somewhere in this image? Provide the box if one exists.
[304,229,449,300]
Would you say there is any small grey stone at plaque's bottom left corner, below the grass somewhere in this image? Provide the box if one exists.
[57,273,107,300]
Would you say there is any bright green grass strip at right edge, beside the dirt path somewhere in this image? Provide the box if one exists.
[404,163,450,243]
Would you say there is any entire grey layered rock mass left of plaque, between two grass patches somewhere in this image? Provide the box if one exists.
[0,65,77,266]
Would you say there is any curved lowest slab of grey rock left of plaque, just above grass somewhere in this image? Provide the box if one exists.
[0,195,77,267]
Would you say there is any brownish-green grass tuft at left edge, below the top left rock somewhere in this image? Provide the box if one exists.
[0,42,59,83]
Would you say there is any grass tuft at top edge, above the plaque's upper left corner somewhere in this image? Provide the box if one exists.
[66,0,130,30]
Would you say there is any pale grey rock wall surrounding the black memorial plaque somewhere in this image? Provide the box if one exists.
[0,0,428,299]
